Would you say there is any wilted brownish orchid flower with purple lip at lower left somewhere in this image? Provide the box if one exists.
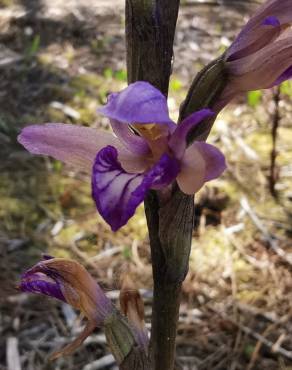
[19,256,115,359]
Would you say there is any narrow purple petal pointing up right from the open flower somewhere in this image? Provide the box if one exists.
[169,109,215,159]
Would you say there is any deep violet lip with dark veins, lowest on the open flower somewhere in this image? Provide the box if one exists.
[92,146,179,231]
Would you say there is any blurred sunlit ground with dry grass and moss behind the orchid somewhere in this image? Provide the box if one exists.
[0,0,292,370]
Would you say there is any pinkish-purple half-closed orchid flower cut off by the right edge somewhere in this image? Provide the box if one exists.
[214,0,292,112]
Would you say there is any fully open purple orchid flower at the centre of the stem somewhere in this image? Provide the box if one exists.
[18,81,226,231]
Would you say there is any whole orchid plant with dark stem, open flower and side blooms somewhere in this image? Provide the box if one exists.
[18,0,292,370]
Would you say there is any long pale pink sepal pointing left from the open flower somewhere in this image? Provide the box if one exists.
[18,123,121,172]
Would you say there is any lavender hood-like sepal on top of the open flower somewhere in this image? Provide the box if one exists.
[99,81,173,125]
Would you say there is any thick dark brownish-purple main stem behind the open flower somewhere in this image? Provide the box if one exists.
[126,0,188,370]
